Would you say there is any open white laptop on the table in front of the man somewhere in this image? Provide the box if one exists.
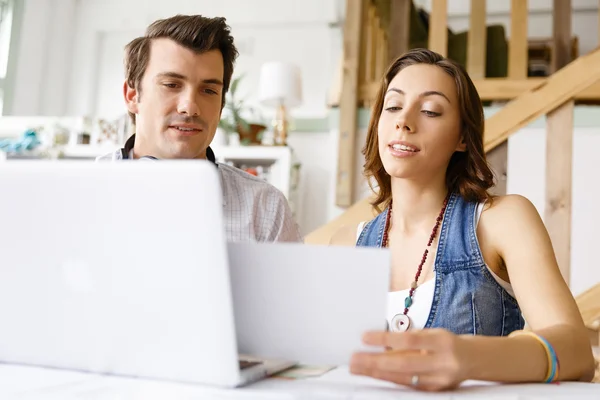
[0,161,387,387]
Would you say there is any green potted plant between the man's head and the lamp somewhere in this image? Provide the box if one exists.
[219,75,267,145]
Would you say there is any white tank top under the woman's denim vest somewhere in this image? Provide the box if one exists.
[356,202,515,329]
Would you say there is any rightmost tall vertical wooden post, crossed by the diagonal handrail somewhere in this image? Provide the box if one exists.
[544,0,575,284]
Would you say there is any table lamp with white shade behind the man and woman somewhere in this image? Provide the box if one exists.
[258,62,302,146]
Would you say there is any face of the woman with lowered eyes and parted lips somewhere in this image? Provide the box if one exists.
[377,64,465,179]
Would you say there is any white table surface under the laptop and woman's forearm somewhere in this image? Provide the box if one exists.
[0,365,600,400]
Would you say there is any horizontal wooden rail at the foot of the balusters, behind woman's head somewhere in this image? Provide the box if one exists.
[360,78,600,101]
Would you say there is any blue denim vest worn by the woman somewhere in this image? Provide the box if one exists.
[356,193,525,336]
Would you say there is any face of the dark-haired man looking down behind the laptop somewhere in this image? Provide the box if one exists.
[124,38,224,159]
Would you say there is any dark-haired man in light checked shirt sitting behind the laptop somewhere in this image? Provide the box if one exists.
[98,15,301,241]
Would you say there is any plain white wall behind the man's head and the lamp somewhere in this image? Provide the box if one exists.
[11,0,340,117]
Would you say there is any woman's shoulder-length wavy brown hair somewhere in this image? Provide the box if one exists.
[362,49,494,211]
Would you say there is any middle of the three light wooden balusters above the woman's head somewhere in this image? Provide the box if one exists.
[467,0,487,79]
